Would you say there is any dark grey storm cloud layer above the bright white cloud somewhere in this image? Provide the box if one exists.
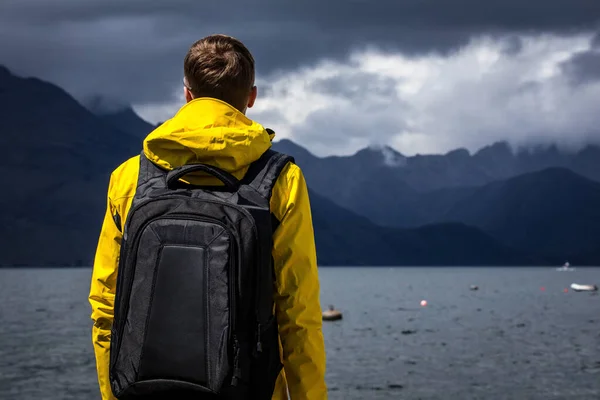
[0,0,600,103]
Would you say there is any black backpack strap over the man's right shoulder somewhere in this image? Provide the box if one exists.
[243,149,294,200]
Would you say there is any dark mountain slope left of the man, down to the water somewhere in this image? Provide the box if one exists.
[0,68,141,265]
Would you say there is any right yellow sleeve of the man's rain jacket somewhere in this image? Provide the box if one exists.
[273,164,327,400]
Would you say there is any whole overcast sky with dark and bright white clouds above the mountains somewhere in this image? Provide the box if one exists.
[0,0,600,155]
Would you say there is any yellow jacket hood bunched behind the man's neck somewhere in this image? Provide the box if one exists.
[144,98,275,179]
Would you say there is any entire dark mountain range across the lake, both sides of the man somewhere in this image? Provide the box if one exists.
[0,67,600,266]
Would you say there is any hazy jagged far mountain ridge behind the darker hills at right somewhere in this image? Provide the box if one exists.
[274,139,600,227]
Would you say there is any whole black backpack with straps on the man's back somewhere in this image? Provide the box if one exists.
[110,150,294,400]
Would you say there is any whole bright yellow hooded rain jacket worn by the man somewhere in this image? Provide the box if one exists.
[89,98,327,400]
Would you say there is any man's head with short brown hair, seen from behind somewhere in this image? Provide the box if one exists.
[183,35,257,113]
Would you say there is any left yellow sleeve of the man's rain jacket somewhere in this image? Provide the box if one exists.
[89,178,122,400]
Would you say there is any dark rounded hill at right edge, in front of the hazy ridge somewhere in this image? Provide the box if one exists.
[444,168,600,262]
